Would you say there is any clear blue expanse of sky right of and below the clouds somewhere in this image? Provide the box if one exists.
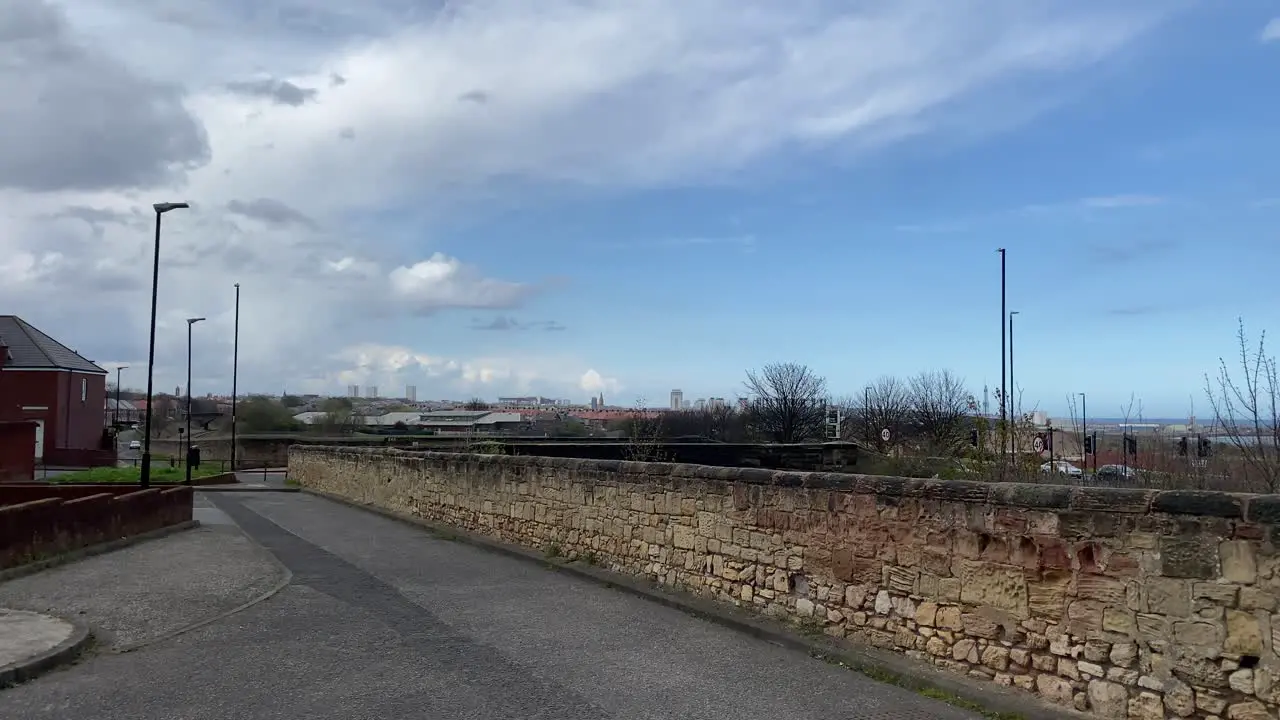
[376,3,1280,416]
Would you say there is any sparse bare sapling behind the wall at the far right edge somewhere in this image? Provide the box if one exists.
[1204,319,1280,492]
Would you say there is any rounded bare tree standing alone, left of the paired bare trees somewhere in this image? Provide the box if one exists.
[745,363,827,442]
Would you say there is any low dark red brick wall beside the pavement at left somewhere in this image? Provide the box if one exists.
[0,486,193,570]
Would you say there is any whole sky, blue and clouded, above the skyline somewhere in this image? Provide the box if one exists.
[0,0,1280,418]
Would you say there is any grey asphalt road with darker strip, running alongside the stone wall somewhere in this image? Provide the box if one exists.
[0,493,975,720]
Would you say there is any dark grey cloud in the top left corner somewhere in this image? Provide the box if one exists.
[0,0,210,191]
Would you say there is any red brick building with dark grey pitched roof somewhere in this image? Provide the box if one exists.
[0,315,115,466]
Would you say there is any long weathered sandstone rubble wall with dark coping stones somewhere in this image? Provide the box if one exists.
[289,446,1280,720]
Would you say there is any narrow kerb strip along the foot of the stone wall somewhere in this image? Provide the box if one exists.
[300,488,1089,720]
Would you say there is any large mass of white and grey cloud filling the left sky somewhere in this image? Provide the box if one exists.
[0,0,1166,392]
